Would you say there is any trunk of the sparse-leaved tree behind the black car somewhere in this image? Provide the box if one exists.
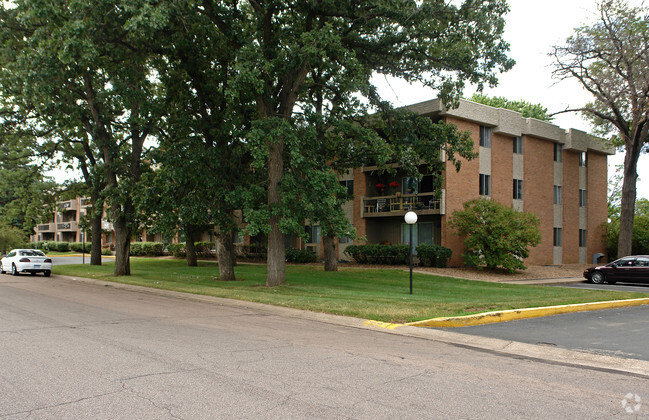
[617,146,641,258]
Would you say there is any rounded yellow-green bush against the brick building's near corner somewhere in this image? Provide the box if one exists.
[449,199,541,272]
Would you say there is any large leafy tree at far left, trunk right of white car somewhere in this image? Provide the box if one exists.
[0,0,160,275]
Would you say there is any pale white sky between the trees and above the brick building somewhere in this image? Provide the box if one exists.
[375,0,649,198]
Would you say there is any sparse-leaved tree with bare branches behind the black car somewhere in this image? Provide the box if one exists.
[552,0,649,256]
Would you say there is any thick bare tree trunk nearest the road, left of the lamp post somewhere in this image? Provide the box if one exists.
[266,140,286,287]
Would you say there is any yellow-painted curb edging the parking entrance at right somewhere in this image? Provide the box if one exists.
[402,298,649,329]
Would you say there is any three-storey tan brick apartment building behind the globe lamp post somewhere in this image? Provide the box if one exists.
[322,100,614,266]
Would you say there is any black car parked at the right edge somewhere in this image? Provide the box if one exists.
[584,255,649,284]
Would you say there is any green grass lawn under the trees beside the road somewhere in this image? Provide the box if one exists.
[54,258,649,323]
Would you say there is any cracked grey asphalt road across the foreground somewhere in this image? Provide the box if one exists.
[0,275,649,419]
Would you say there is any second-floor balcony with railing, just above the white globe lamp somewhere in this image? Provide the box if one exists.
[361,190,445,217]
